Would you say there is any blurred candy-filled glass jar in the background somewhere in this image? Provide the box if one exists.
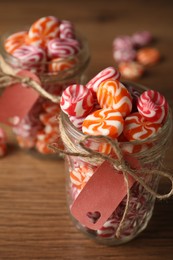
[1,16,90,154]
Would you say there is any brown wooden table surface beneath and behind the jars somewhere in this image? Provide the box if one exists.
[0,0,173,260]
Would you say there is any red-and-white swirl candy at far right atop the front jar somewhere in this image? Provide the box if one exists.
[137,90,168,123]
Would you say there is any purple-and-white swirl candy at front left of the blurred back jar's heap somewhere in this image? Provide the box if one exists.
[13,45,46,73]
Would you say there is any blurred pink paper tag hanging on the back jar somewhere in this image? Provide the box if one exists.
[0,71,40,125]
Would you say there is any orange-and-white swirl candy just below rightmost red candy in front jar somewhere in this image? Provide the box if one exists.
[123,112,161,141]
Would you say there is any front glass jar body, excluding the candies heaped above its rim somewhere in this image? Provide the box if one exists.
[60,83,172,245]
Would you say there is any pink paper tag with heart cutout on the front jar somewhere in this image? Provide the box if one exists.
[71,161,135,230]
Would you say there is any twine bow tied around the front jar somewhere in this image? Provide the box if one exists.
[49,118,173,237]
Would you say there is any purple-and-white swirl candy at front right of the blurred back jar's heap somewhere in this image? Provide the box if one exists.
[47,39,80,59]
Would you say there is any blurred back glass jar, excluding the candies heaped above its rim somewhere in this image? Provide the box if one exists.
[0,29,90,154]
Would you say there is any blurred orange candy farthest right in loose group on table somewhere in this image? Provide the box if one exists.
[136,47,160,66]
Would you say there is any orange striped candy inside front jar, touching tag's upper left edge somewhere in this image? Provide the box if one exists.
[70,166,94,190]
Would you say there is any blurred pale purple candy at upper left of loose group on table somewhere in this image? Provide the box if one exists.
[113,35,134,50]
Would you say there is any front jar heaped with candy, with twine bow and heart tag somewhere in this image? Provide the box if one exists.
[54,67,173,245]
